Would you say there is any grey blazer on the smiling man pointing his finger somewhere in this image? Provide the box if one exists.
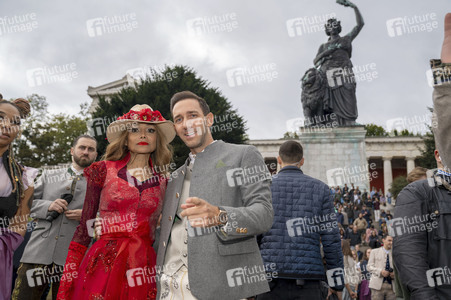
[157,141,274,300]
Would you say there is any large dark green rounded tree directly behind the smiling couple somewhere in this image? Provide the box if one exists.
[91,66,248,166]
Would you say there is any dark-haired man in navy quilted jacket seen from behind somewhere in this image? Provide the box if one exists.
[257,141,345,300]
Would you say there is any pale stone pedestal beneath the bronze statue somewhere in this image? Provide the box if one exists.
[298,125,375,192]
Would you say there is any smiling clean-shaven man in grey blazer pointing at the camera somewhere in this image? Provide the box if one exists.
[156,91,273,300]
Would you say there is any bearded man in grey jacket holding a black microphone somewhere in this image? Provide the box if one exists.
[12,135,97,300]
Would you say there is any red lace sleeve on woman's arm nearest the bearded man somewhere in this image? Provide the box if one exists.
[72,161,107,247]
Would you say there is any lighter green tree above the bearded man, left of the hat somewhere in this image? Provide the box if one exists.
[15,94,87,167]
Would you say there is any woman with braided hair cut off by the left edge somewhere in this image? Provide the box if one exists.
[0,95,37,299]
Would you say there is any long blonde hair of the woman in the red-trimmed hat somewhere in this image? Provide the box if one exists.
[102,124,172,175]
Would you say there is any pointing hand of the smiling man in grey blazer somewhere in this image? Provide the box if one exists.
[181,197,220,227]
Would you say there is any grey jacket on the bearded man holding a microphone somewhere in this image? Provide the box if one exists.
[20,168,86,266]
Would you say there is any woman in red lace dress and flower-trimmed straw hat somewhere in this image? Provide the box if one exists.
[58,105,175,300]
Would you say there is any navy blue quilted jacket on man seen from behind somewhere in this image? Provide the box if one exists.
[260,166,343,280]
